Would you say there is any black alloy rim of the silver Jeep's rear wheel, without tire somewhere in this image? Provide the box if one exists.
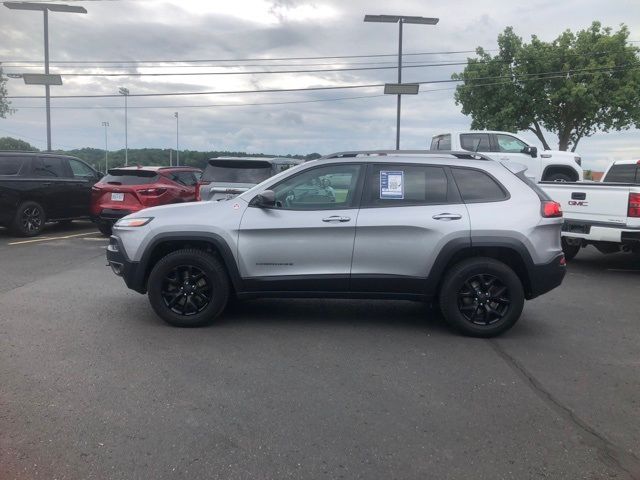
[458,274,511,325]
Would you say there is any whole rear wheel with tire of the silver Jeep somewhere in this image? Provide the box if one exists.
[440,257,524,337]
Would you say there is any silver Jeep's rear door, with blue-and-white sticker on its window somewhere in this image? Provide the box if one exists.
[351,163,470,293]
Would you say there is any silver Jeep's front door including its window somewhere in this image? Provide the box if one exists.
[238,163,363,292]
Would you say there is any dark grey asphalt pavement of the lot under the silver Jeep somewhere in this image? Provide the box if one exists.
[0,222,640,480]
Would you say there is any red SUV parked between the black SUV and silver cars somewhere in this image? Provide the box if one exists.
[91,167,202,236]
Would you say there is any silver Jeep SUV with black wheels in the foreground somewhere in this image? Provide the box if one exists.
[107,151,565,337]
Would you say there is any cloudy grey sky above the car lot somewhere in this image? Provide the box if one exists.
[0,0,640,169]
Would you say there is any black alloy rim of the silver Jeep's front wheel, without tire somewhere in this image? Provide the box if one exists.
[161,265,213,316]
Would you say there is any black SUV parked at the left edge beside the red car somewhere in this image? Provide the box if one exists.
[0,152,102,237]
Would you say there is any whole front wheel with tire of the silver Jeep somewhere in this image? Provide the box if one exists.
[147,249,230,327]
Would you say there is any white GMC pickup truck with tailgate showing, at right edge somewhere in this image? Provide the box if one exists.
[539,160,640,260]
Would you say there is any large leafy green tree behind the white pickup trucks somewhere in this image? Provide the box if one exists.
[452,22,640,151]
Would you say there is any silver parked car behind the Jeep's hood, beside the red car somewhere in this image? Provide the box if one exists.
[196,157,302,201]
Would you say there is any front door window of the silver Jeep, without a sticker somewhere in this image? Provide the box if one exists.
[272,164,362,210]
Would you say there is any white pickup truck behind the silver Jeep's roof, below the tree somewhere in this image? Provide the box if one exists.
[430,131,582,182]
